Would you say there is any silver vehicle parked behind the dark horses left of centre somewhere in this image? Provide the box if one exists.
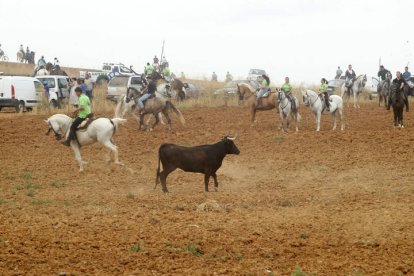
[106,75,142,102]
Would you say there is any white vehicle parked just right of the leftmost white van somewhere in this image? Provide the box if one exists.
[36,75,69,108]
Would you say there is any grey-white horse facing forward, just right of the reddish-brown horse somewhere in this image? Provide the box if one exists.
[277,90,301,131]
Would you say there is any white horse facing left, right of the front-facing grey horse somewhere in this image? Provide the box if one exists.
[302,90,345,131]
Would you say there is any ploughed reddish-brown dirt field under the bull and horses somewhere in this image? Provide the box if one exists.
[0,103,414,275]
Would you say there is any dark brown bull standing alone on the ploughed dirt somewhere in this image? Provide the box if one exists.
[154,136,240,193]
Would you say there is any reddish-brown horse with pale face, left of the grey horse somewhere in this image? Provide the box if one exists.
[237,83,277,123]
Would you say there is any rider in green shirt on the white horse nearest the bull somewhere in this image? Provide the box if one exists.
[61,87,91,147]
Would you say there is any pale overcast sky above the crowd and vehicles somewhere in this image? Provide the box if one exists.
[0,0,414,84]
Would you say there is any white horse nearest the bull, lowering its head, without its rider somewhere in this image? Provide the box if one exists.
[45,114,126,172]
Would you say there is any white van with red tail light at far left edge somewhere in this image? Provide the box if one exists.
[0,76,44,112]
